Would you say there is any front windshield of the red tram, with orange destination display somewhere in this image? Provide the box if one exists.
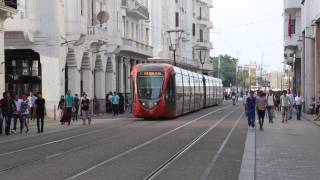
[137,72,164,99]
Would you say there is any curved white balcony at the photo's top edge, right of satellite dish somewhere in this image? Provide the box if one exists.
[121,0,149,20]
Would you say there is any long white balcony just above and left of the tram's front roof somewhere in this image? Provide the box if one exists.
[120,38,153,57]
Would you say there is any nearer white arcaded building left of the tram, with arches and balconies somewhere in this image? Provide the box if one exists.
[2,0,153,117]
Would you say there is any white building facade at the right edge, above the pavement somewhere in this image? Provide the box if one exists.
[284,0,320,110]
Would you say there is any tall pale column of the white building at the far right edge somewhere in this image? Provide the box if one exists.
[305,38,315,105]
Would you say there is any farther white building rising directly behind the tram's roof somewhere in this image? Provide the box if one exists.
[151,0,213,72]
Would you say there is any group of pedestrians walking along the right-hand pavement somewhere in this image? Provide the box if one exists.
[243,90,306,130]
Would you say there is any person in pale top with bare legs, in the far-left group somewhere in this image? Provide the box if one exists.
[19,94,31,134]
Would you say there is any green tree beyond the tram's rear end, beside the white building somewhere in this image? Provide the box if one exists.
[210,55,238,87]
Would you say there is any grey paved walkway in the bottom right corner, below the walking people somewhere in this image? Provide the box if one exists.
[256,114,320,180]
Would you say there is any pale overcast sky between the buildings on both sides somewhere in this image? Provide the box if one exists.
[211,0,284,71]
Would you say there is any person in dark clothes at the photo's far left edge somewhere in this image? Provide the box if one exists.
[1,92,17,136]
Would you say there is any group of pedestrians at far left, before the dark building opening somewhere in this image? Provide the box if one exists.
[0,92,46,136]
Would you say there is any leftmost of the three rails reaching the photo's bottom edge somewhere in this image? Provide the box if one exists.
[66,105,232,180]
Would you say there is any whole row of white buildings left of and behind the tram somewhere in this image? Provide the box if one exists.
[0,0,213,117]
